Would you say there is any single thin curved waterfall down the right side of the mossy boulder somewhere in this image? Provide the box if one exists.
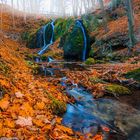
[76,20,87,61]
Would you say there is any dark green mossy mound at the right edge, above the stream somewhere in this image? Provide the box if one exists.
[125,68,140,82]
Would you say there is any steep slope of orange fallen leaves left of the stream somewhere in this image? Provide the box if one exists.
[0,4,77,140]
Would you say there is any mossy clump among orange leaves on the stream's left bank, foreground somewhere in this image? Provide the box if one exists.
[48,94,67,116]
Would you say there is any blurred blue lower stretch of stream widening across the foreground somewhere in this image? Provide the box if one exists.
[61,77,140,140]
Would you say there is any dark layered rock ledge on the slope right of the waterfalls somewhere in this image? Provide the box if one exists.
[91,32,129,58]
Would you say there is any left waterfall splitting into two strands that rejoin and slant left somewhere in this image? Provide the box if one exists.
[38,21,54,55]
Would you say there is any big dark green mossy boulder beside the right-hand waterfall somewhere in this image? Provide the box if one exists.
[60,20,90,60]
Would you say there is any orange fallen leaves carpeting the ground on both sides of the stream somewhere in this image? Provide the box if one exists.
[0,1,140,140]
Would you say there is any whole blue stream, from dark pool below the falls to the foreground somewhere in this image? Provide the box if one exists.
[34,58,140,140]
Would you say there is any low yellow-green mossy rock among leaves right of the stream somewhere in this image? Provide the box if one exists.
[105,84,132,96]
